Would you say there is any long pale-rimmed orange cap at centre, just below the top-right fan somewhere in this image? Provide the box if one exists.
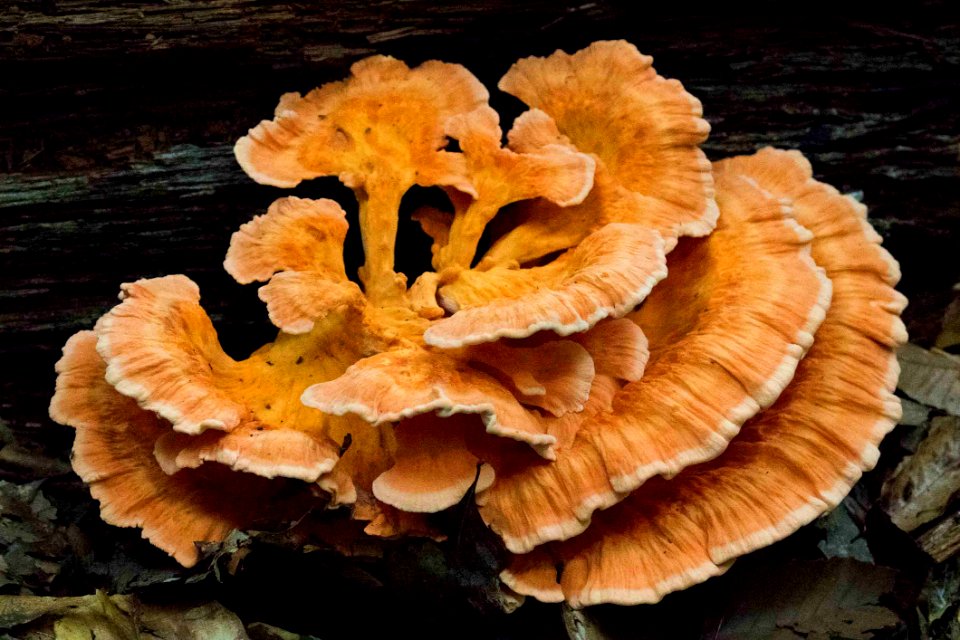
[423,224,666,349]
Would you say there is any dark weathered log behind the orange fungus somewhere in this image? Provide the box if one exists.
[0,0,960,636]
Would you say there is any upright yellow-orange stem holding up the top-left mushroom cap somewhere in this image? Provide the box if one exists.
[356,181,412,307]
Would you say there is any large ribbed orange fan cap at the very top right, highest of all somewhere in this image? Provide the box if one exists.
[499,41,717,246]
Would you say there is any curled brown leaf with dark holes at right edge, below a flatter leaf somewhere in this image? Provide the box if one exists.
[881,416,960,531]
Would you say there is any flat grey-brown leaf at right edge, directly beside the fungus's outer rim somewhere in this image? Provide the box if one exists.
[897,344,960,416]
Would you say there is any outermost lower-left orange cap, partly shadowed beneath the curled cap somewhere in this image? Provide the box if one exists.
[50,331,310,566]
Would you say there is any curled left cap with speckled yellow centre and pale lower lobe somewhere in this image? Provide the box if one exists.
[97,276,367,480]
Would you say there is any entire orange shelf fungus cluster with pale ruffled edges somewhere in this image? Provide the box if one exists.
[51,42,906,606]
